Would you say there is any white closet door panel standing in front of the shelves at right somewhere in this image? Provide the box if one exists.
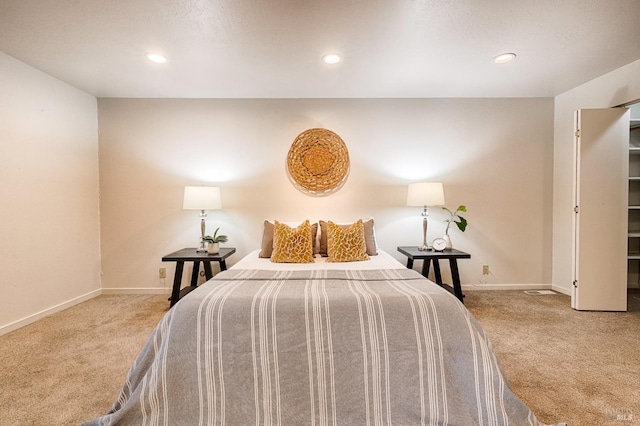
[571,108,629,311]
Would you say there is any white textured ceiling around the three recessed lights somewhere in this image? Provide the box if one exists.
[0,0,640,98]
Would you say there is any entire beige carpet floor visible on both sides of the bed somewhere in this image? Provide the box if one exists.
[0,291,640,426]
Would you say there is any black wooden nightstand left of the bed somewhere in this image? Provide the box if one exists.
[162,247,236,307]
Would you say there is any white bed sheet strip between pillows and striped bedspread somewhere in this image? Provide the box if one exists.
[231,249,406,271]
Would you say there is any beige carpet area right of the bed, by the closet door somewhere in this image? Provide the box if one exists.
[466,291,640,426]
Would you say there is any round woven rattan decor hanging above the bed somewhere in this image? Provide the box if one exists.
[287,128,349,195]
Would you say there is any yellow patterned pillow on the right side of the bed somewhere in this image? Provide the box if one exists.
[327,220,369,262]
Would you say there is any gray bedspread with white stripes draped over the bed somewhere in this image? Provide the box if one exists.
[86,269,552,426]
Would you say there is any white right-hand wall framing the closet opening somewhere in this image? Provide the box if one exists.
[553,60,640,294]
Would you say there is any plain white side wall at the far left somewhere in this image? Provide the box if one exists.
[0,52,100,334]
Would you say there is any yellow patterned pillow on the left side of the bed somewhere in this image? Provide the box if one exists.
[271,220,315,263]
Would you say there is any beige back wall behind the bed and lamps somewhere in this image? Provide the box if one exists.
[98,99,553,291]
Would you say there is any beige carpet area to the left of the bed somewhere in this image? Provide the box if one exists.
[0,295,169,426]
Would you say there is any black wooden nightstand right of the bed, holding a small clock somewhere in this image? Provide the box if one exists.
[398,247,471,303]
